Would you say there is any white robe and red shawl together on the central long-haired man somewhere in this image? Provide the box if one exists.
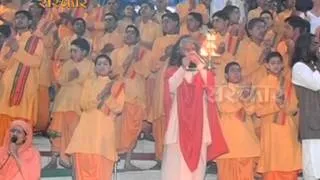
[161,49,228,180]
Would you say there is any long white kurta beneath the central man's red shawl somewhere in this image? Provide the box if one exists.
[161,68,211,180]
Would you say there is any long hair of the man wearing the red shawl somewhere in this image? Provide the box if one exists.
[169,35,200,67]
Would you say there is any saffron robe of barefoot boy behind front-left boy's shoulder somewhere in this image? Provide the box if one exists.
[48,59,94,161]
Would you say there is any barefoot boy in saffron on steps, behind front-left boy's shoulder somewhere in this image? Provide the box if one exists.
[47,38,94,168]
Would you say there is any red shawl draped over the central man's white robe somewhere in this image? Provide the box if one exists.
[164,67,228,171]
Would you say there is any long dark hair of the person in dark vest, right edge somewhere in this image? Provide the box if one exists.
[291,33,317,67]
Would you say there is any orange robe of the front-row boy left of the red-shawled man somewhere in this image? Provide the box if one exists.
[66,77,124,180]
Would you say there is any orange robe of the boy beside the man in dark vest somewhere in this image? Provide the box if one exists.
[256,75,302,180]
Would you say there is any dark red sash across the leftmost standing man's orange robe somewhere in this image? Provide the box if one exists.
[9,36,40,106]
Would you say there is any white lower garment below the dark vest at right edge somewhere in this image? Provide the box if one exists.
[302,139,320,180]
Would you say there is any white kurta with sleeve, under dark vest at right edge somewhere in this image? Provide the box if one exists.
[292,62,320,180]
